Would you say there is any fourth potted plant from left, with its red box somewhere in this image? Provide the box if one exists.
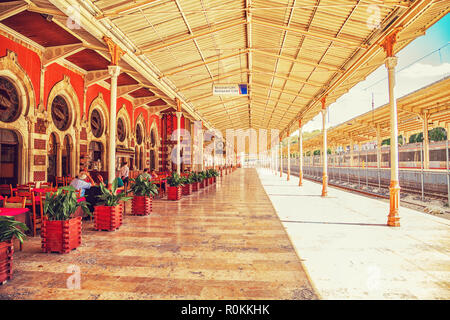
[130,176,158,216]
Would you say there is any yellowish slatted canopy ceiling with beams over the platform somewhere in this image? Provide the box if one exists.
[0,0,450,139]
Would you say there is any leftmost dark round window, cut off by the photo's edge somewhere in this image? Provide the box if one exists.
[0,77,20,122]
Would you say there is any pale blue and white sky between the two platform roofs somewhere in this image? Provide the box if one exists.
[292,14,450,135]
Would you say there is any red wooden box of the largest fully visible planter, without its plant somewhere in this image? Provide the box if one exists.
[41,217,82,253]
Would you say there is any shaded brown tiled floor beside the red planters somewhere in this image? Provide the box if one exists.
[0,169,318,299]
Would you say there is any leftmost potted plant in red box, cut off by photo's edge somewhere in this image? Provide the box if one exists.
[0,216,28,284]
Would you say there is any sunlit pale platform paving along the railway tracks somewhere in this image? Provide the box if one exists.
[256,169,450,299]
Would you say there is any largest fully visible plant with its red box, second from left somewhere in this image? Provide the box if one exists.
[41,186,91,253]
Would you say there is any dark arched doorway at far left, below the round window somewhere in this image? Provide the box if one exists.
[0,129,19,185]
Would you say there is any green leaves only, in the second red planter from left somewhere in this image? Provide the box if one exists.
[44,186,91,221]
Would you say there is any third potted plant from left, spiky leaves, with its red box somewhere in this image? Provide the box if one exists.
[94,178,132,231]
